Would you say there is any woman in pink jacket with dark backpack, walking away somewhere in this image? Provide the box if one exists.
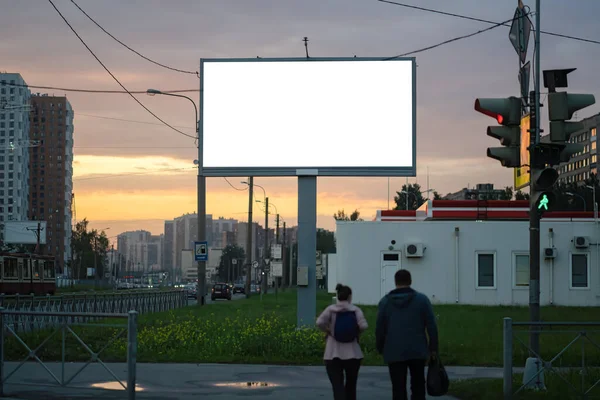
[317,284,368,400]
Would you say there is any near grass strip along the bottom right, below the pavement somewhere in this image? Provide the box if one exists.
[448,369,600,400]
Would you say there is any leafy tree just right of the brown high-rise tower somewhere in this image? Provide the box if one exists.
[71,218,109,279]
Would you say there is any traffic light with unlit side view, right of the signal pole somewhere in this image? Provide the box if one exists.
[548,92,596,162]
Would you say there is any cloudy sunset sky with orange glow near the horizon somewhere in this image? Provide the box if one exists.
[0,0,600,236]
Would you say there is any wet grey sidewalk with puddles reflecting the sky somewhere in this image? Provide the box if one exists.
[0,362,510,400]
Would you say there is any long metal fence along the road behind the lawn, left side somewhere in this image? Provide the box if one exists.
[0,290,188,332]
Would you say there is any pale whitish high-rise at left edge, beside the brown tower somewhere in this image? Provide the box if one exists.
[0,73,31,222]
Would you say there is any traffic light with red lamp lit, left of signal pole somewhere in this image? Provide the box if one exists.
[475,97,521,168]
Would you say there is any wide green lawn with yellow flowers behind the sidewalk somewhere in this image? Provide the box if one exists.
[5,290,600,366]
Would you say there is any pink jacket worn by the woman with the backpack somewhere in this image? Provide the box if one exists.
[317,301,369,360]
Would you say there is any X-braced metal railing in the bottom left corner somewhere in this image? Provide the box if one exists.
[0,307,138,400]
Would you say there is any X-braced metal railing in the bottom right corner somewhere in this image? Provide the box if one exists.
[503,318,600,400]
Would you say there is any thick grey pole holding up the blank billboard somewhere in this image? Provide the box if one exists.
[297,175,317,328]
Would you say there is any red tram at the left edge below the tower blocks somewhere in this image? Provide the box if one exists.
[0,253,56,295]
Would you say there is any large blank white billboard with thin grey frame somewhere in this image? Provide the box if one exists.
[200,58,416,176]
